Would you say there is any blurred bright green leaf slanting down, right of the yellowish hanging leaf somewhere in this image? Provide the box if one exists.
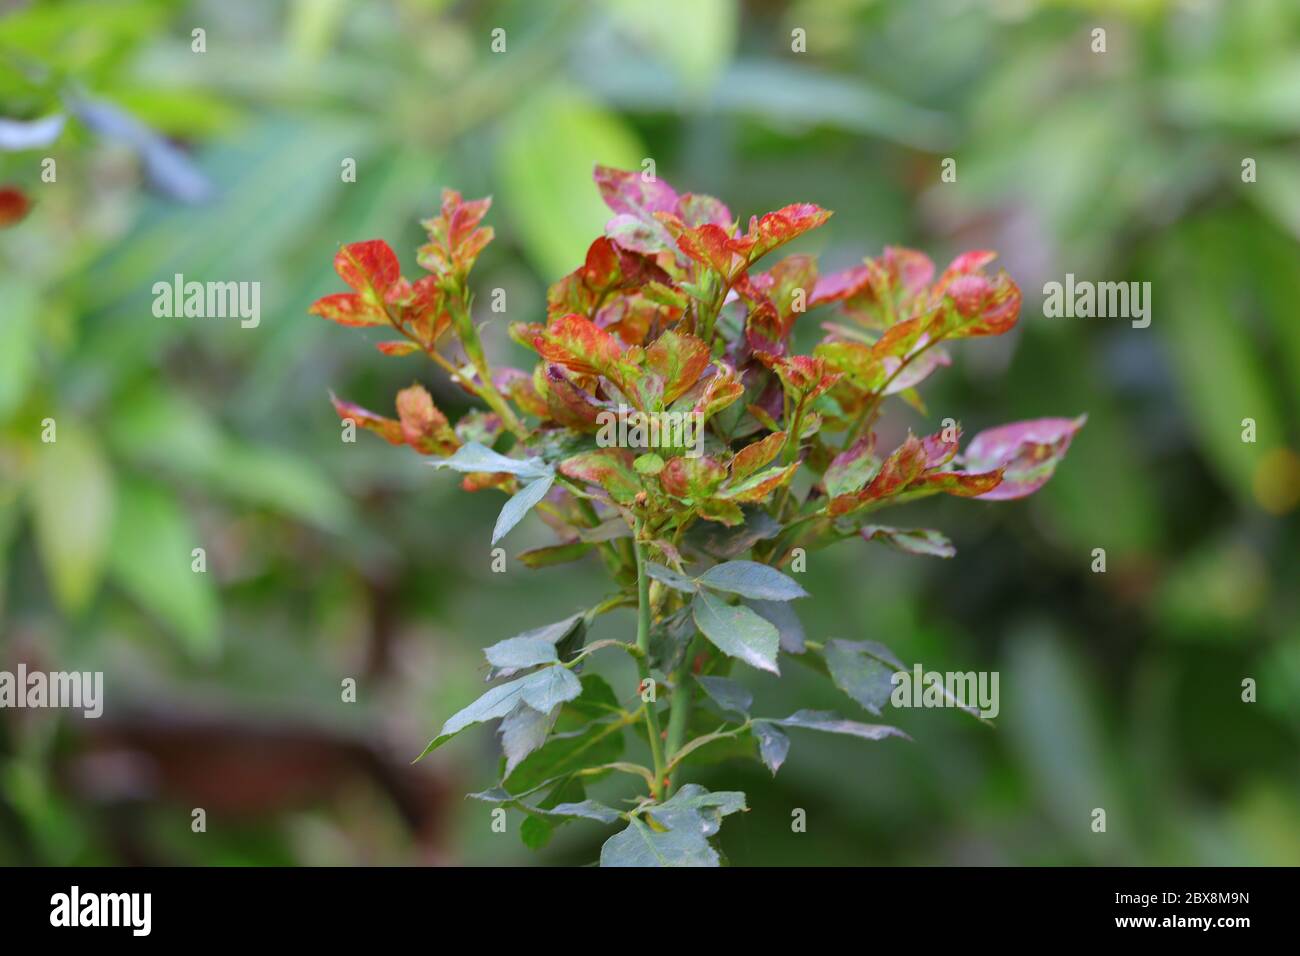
[108,483,220,658]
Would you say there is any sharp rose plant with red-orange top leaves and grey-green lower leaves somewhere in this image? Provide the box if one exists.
[311,166,1084,865]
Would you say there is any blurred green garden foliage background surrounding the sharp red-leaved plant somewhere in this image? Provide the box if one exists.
[0,0,1300,865]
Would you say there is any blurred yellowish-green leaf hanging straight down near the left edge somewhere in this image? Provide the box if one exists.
[27,419,114,611]
